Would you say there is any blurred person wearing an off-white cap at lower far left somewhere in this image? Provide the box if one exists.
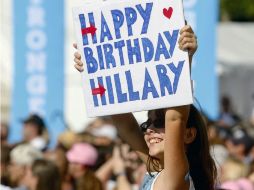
[9,144,43,190]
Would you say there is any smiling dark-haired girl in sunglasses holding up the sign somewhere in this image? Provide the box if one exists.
[74,26,216,190]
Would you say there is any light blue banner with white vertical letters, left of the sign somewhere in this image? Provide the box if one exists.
[10,0,64,147]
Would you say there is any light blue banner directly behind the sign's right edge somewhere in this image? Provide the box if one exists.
[183,0,219,119]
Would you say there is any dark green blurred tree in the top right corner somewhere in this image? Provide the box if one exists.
[220,0,254,22]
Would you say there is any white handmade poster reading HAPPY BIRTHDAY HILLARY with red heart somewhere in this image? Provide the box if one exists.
[73,0,193,117]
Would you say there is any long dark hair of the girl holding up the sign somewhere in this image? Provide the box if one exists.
[147,105,217,190]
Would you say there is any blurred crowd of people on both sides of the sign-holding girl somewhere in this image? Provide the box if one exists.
[1,97,254,190]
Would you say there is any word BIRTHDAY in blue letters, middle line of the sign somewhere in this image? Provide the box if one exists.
[84,30,179,74]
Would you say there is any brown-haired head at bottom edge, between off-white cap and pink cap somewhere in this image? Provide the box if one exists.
[24,159,61,190]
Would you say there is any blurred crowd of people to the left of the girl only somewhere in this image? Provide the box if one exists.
[1,115,146,190]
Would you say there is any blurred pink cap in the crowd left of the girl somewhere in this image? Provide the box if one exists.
[66,143,98,166]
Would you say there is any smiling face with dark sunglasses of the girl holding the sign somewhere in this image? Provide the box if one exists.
[144,111,165,160]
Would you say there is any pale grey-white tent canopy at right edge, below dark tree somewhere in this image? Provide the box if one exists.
[217,22,254,68]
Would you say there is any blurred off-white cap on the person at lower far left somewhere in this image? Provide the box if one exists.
[11,144,43,166]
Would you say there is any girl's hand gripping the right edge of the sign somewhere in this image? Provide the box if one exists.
[178,25,198,58]
